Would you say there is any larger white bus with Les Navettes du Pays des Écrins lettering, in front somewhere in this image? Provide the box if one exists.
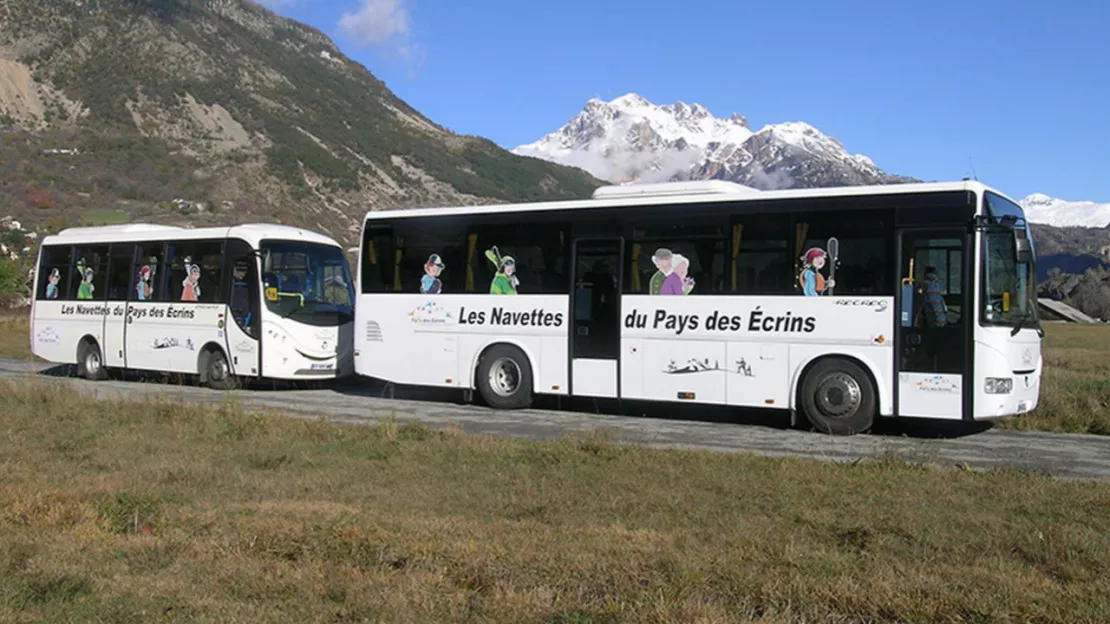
[355,181,1042,434]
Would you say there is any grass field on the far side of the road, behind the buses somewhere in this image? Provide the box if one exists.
[0,315,1110,435]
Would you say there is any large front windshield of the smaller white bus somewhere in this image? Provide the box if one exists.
[261,241,354,325]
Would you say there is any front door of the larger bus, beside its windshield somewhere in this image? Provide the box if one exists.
[895,228,971,419]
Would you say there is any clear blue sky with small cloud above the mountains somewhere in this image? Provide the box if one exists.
[263,0,1110,201]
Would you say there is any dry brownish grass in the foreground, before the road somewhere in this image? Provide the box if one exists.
[0,382,1110,624]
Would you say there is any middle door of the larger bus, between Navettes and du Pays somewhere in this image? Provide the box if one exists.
[569,239,624,399]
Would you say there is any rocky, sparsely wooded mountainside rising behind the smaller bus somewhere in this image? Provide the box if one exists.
[0,0,599,242]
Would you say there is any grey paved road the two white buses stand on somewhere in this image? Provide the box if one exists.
[0,359,1110,480]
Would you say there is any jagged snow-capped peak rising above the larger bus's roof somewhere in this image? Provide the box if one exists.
[513,93,912,189]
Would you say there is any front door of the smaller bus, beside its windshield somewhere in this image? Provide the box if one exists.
[225,239,262,376]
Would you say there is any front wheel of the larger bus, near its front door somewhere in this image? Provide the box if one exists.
[799,359,875,435]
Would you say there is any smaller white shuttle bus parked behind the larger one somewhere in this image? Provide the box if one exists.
[31,223,354,389]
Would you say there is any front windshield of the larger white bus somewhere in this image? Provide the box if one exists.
[981,193,1039,329]
